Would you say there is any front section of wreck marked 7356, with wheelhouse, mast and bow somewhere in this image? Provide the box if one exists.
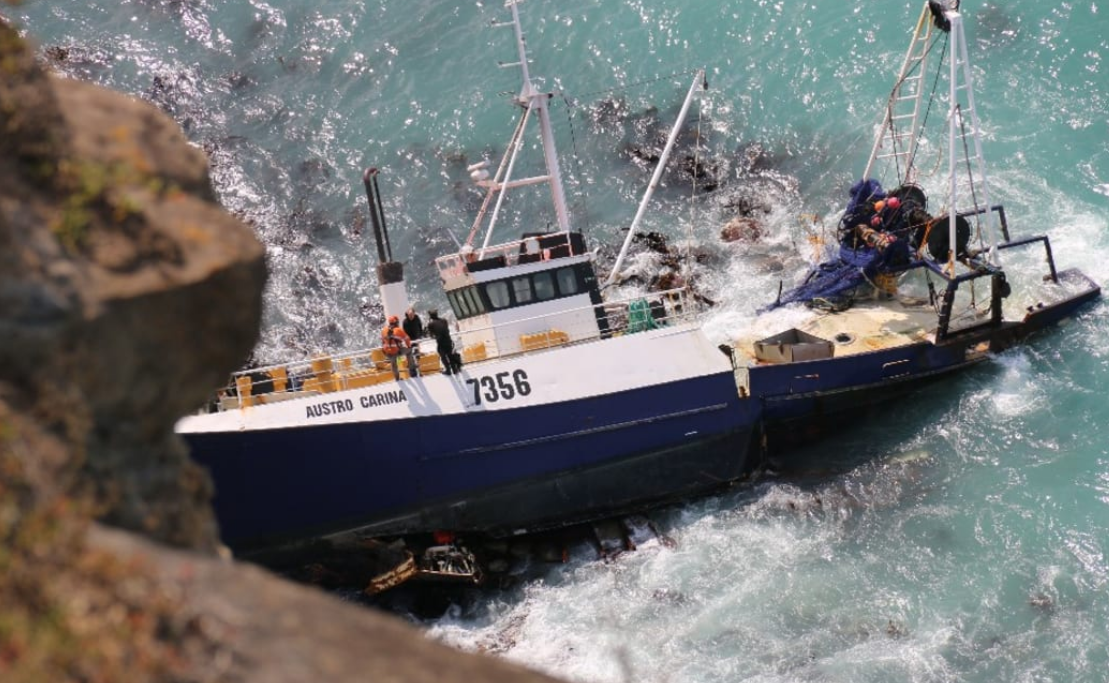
[177,0,757,553]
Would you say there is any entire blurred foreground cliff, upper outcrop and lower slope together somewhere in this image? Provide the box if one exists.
[0,20,567,683]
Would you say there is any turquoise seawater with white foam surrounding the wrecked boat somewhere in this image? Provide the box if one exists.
[6,0,1109,682]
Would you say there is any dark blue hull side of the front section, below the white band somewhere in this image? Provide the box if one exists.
[184,373,757,550]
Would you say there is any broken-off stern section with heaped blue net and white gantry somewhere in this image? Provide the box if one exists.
[733,0,1100,450]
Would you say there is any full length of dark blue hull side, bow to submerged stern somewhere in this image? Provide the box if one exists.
[183,273,1100,551]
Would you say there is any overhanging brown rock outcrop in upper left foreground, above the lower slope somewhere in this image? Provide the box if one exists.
[0,21,265,550]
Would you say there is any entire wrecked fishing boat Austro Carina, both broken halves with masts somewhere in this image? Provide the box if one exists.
[177,0,1100,552]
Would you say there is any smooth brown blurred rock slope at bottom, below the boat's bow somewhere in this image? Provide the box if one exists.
[91,530,563,683]
